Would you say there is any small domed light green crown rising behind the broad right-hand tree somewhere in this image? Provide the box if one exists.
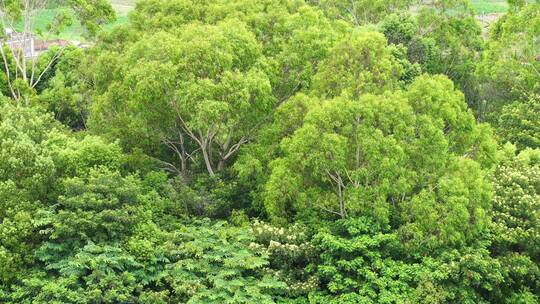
[314,31,403,98]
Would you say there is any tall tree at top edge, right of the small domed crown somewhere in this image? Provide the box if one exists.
[381,0,484,106]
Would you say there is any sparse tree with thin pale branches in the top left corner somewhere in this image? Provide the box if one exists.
[0,0,115,105]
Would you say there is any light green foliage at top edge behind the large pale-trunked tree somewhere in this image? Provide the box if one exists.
[125,0,348,100]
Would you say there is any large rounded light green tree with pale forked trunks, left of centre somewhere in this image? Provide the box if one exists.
[91,21,275,175]
